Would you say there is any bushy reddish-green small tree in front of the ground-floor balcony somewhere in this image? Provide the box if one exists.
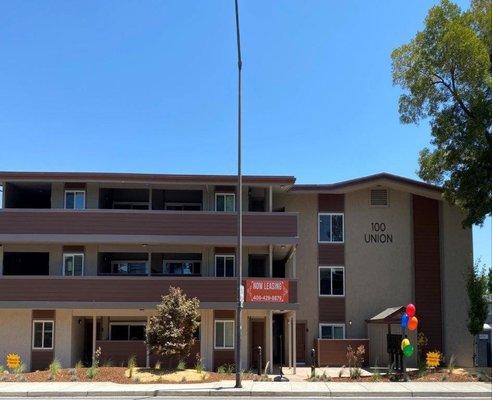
[146,287,200,358]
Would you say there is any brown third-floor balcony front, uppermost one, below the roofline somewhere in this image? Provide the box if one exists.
[0,209,298,245]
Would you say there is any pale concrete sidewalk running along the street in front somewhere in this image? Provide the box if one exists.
[0,381,492,398]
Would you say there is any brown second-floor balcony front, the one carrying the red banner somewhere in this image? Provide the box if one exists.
[0,276,297,309]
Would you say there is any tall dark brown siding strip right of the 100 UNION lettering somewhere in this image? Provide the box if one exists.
[413,195,442,350]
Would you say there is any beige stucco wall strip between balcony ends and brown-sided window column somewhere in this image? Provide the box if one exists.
[273,194,318,363]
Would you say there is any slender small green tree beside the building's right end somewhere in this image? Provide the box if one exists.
[466,263,487,365]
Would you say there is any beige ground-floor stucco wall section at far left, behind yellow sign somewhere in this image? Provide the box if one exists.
[0,309,32,368]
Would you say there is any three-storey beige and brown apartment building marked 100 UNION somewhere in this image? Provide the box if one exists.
[0,172,472,370]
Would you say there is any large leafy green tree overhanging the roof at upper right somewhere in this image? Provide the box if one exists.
[391,0,492,226]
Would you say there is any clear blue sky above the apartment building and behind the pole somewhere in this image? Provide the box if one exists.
[0,0,492,265]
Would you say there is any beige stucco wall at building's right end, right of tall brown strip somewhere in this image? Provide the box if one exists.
[440,202,473,366]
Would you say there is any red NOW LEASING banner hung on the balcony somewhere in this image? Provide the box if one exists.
[246,279,289,303]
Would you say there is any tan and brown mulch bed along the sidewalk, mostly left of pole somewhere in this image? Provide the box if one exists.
[0,367,256,384]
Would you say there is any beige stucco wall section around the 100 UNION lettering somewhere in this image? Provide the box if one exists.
[345,190,413,338]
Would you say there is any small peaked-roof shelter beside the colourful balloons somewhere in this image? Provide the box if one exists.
[366,306,417,367]
